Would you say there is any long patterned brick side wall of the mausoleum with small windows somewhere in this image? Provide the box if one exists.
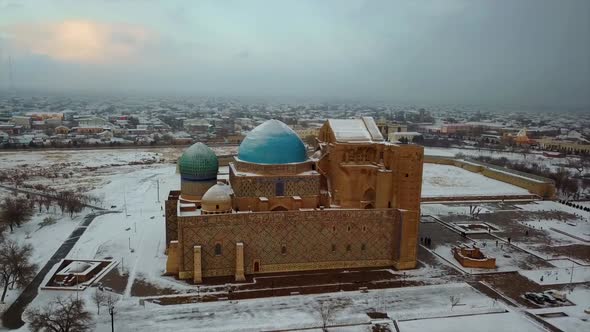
[173,209,400,278]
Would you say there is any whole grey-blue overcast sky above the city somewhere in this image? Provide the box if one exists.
[0,0,590,105]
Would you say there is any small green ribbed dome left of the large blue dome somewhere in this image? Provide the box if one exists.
[178,143,219,181]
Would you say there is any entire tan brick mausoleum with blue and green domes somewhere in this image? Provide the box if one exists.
[166,118,424,283]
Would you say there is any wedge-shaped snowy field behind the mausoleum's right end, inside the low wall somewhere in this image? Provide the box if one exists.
[422,164,529,197]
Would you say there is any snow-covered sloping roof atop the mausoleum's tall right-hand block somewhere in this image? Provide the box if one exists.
[328,117,383,142]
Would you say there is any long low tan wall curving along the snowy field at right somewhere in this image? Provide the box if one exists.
[424,156,555,199]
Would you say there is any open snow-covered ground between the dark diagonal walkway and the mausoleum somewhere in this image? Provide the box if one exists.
[69,165,188,296]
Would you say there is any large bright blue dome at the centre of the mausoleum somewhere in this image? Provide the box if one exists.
[238,120,307,164]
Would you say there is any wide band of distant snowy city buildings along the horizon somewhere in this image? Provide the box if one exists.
[0,96,590,154]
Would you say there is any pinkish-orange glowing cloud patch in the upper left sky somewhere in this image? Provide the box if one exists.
[0,20,158,64]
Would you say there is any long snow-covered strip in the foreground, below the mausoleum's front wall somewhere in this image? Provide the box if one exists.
[89,283,506,332]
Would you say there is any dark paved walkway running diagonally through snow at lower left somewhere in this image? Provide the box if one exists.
[2,211,118,329]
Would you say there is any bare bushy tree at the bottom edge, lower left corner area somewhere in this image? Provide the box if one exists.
[25,297,94,332]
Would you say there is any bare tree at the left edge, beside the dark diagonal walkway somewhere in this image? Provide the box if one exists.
[0,240,37,302]
